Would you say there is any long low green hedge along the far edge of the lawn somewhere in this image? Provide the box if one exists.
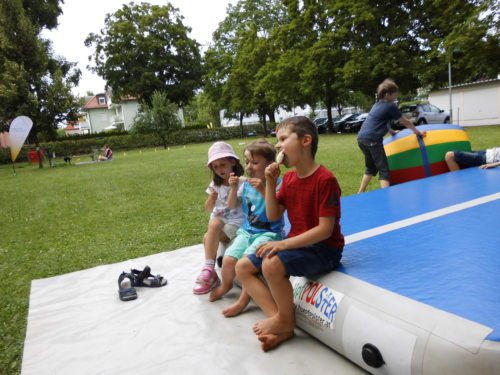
[0,124,264,164]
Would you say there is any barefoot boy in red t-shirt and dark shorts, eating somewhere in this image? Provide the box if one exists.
[236,116,344,351]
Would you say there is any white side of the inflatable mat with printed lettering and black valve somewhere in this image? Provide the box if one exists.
[293,271,500,375]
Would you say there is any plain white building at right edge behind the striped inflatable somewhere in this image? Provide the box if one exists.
[429,78,500,126]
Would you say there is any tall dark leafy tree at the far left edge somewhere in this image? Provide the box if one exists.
[0,0,80,142]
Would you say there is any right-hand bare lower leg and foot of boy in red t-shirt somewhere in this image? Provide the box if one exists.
[253,256,295,336]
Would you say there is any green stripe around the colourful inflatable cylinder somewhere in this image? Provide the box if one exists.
[387,141,471,171]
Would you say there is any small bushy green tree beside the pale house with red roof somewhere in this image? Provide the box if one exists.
[131,91,181,148]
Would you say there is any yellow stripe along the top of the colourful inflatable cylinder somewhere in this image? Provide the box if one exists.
[384,129,470,156]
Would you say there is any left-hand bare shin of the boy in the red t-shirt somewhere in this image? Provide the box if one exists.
[236,257,278,316]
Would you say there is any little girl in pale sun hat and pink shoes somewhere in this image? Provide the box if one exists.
[193,142,243,294]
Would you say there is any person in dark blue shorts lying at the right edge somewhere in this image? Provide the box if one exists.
[444,147,500,172]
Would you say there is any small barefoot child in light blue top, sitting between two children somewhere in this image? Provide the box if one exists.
[210,140,283,317]
